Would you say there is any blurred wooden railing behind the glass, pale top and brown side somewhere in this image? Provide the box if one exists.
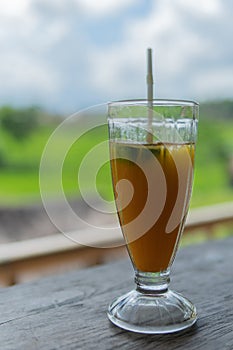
[0,202,233,285]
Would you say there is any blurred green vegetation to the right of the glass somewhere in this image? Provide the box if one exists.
[191,102,233,207]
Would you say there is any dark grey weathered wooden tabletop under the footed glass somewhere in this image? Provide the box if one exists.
[0,238,233,350]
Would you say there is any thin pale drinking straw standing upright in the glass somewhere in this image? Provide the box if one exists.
[146,48,154,143]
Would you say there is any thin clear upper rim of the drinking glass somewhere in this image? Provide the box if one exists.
[108,98,199,107]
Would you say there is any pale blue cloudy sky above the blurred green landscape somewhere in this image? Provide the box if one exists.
[0,0,233,113]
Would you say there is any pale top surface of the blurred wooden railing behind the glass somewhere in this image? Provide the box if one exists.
[0,202,233,265]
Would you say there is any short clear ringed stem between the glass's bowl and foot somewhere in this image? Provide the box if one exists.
[135,270,170,294]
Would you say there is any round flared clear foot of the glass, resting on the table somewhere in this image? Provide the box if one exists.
[108,290,197,334]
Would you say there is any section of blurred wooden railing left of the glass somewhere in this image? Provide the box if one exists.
[0,229,126,286]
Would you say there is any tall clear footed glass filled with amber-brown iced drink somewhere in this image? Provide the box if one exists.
[108,100,198,334]
